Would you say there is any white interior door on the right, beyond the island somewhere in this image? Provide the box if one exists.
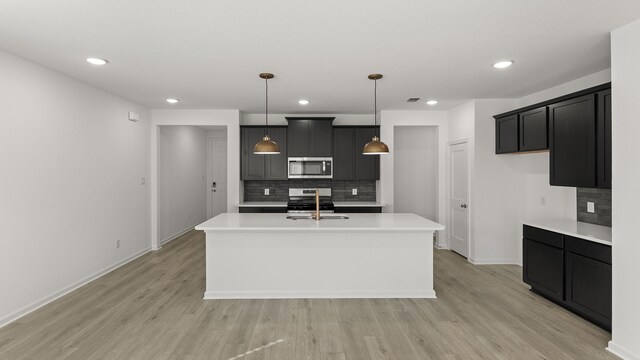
[449,142,469,257]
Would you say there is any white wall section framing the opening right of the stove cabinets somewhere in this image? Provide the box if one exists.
[378,111,448,246]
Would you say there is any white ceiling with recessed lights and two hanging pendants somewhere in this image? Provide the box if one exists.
[0,0,640,114]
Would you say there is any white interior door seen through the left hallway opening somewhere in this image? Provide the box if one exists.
[207,139,227,218]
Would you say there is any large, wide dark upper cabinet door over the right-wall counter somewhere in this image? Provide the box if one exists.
[549,94,596,187]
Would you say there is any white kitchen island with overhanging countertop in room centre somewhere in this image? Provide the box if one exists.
[196,213,444,299]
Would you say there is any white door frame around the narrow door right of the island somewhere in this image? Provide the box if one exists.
[446,138,474,261]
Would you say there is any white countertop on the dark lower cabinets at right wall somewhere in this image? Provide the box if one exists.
[523,219,611,246]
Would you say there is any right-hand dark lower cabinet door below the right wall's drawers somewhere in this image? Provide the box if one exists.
[566,252,611,329]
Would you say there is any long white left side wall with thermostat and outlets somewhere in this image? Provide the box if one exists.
[0,51,150,326]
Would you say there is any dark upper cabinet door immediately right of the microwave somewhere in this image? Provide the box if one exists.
[333,128,356,180]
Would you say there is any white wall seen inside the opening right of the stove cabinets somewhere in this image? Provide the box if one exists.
[392,126,439,219]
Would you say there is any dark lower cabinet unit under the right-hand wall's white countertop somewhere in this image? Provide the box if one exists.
[523,225,611,330]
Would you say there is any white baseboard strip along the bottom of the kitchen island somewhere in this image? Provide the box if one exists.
[204,290,436,300]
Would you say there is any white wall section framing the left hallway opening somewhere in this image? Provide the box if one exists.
[150,109,240,249]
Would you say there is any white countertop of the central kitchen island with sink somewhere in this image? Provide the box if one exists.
[196,213,445,232]
